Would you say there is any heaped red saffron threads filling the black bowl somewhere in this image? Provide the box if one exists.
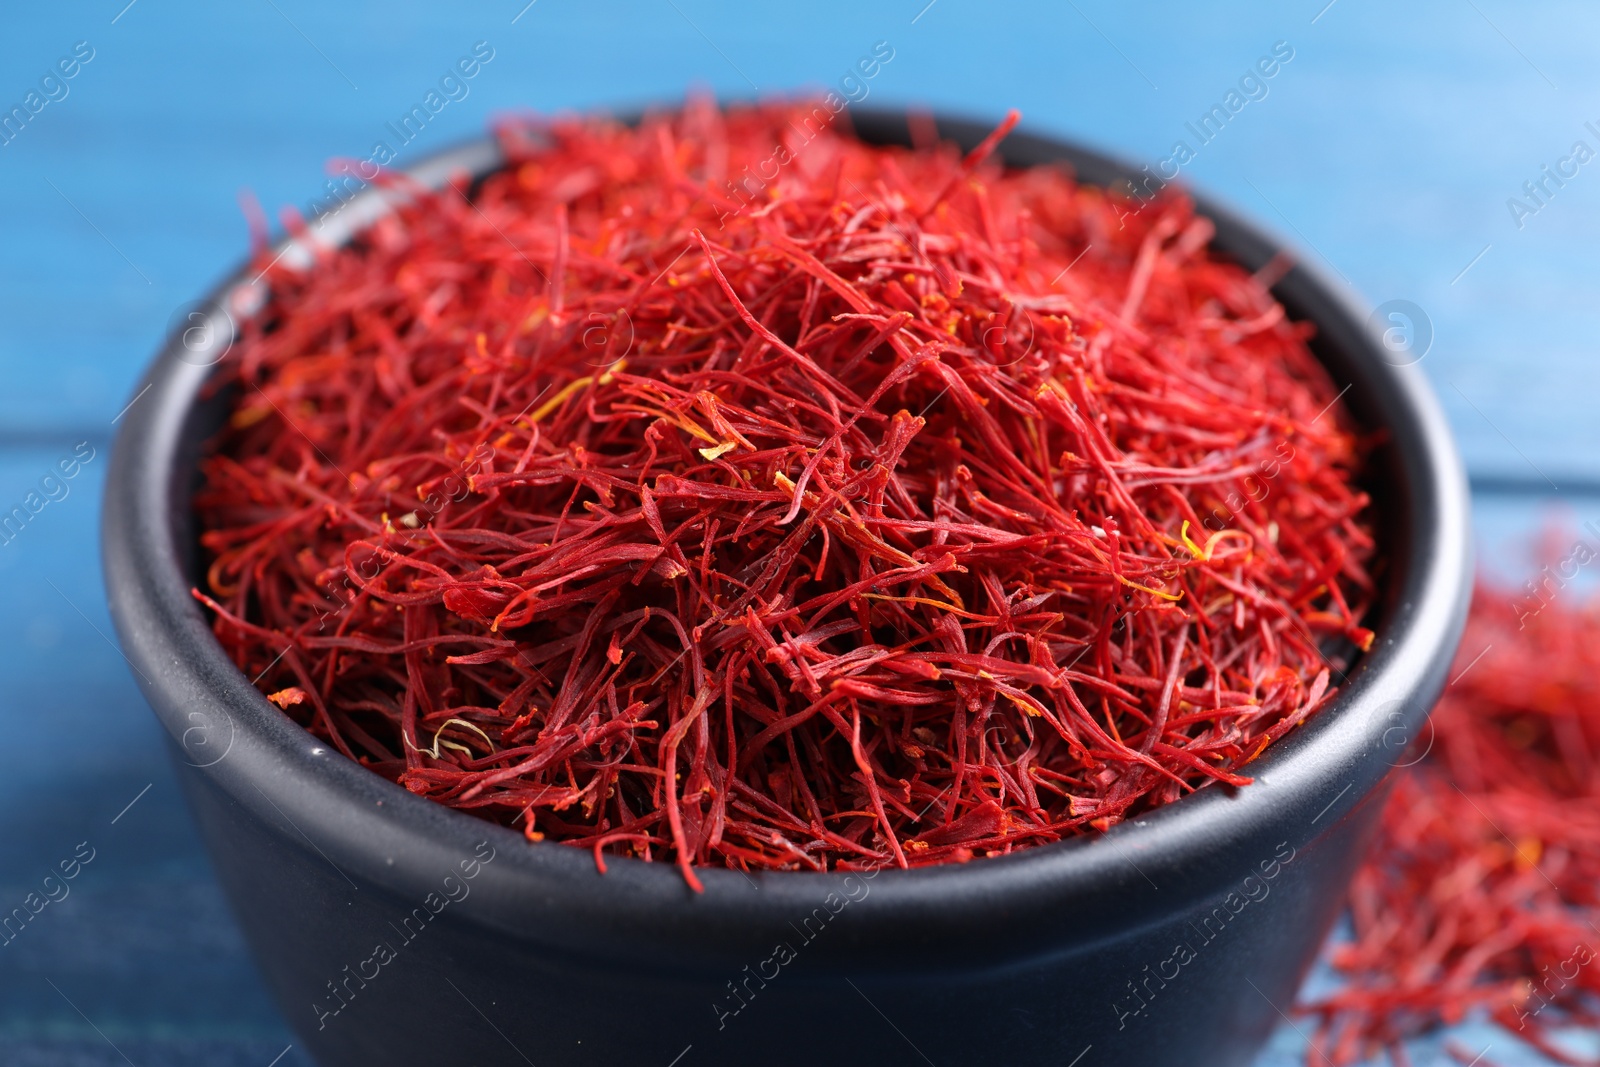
[195,101,1374,889]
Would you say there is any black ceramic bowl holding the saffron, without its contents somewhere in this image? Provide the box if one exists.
[104,112,1469,1067]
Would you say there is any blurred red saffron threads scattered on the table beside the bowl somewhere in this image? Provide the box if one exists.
[1301,566,1600,1067]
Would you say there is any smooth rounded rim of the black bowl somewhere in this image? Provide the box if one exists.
[102,109,1470,966]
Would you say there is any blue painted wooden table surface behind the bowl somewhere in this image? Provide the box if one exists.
[0,0,1600,1067]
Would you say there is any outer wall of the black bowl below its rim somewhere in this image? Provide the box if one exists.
[174,752,1387,1067]
